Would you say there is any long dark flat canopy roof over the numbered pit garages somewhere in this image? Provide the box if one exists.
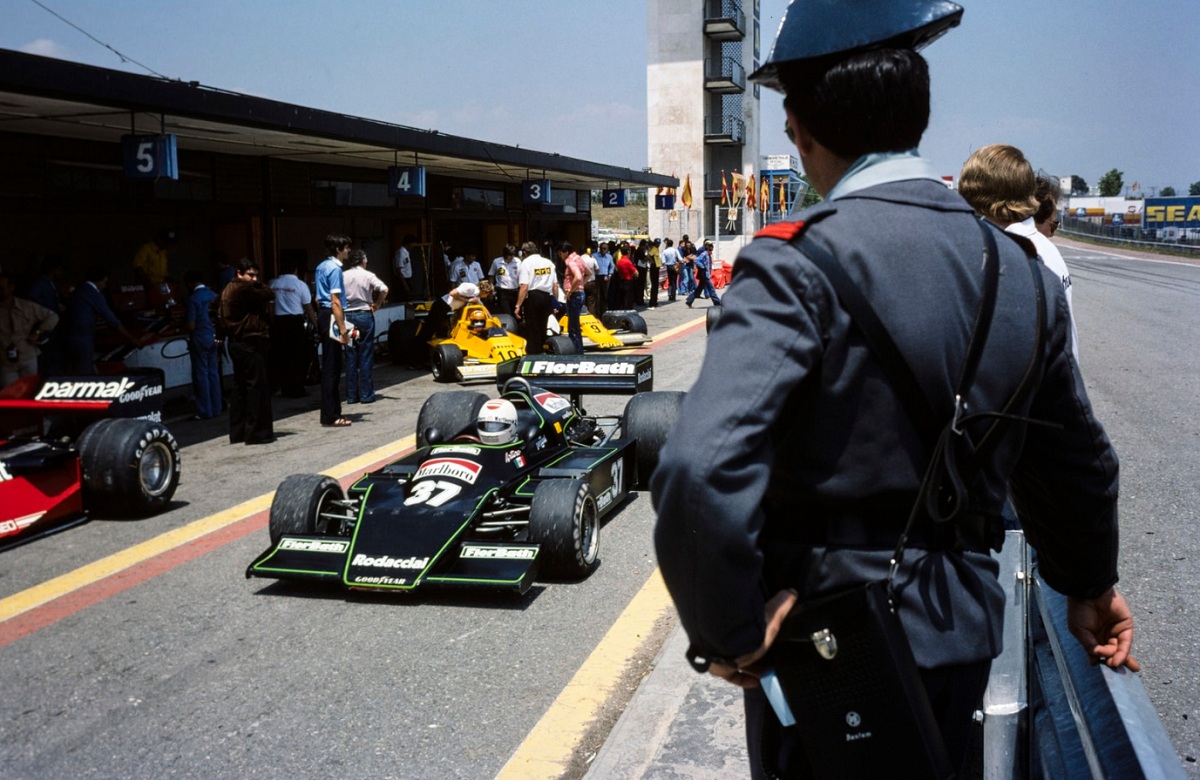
[0,49,678,190]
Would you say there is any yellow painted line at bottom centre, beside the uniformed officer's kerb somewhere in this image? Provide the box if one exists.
[496,569,671,780]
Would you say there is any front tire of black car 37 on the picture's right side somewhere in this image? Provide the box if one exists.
[529,479,600,580]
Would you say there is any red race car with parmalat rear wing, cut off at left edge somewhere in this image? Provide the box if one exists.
[0,370,180,550]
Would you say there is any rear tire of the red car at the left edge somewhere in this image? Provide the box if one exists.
[76,418,180,517]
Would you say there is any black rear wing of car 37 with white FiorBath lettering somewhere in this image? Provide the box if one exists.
[496,355,654,396]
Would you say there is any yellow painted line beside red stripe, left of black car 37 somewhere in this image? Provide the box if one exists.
[0,427,416,623]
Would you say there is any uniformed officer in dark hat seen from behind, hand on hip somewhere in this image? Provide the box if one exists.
[650,0,1138,778]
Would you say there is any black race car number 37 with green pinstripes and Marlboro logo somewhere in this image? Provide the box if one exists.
[246,355,683,593]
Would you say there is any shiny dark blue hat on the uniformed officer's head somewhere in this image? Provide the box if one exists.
[750,0,962,90]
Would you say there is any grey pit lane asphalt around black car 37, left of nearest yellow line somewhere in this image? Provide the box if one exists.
[0,298,703,778]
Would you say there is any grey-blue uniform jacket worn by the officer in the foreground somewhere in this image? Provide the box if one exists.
[650,180,1117,668]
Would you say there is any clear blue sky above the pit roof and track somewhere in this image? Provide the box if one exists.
[9,0,1200,194]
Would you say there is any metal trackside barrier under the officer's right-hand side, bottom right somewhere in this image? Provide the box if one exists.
[983,530,1187,780]
